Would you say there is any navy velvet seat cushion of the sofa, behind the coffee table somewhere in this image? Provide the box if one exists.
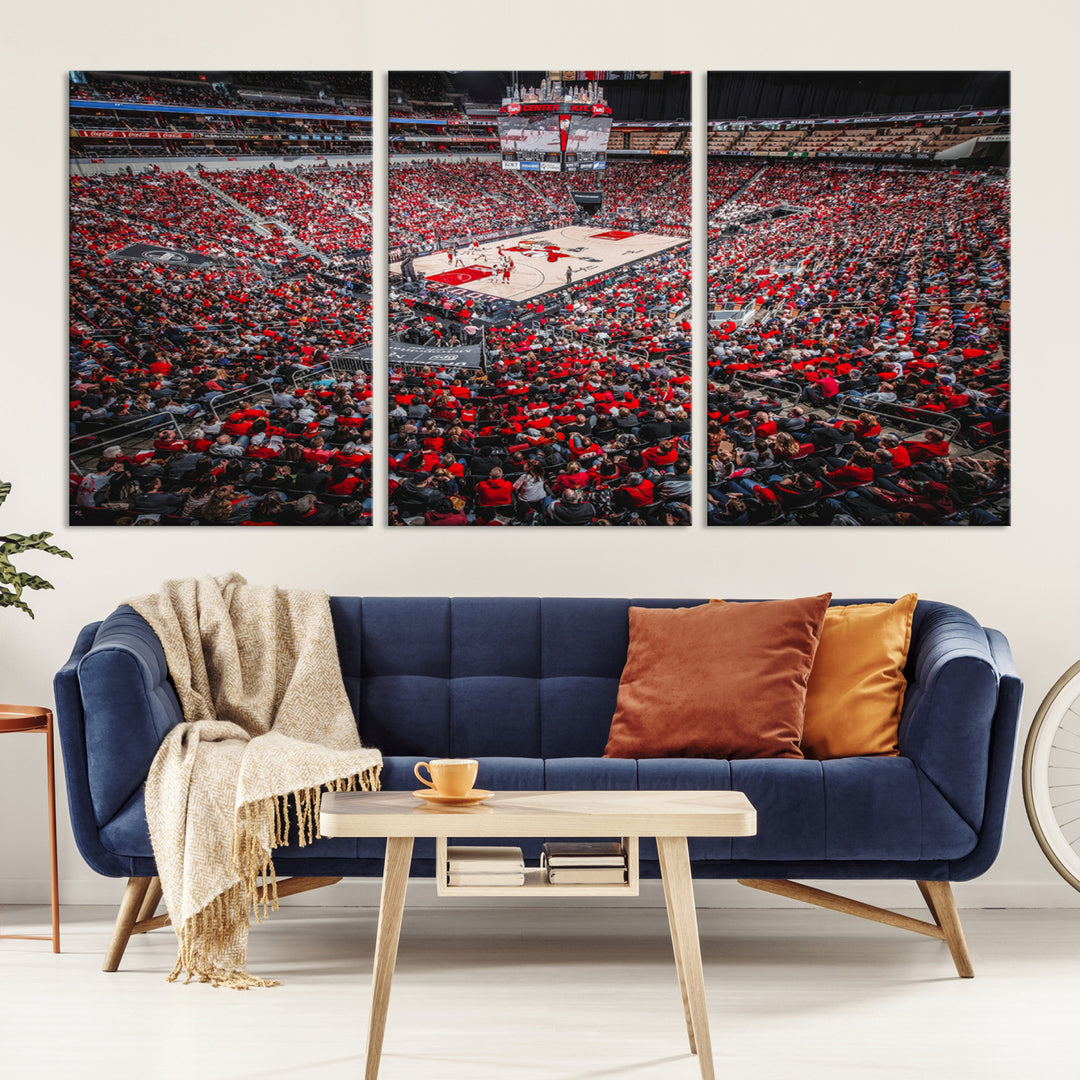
[100,757,975,877]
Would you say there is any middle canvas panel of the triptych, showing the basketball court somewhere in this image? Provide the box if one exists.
[389,72,692,526]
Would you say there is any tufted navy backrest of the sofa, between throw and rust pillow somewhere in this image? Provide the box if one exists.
[330,596,705,757]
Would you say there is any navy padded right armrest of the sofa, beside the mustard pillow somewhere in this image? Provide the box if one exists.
[900,600,1008,833]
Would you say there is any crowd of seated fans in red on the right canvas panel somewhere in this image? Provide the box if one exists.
[708,162,1010,525]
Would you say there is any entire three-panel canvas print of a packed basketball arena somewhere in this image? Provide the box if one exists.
[69,71,1010,526]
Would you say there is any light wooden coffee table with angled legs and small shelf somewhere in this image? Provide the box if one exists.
[320,792,757,1080]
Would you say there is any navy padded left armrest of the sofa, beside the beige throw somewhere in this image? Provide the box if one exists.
[76,606,184,826]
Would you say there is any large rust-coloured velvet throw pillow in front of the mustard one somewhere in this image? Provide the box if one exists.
[604,593,831,758]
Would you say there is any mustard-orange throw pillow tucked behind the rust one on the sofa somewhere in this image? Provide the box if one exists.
[802,593,919,760]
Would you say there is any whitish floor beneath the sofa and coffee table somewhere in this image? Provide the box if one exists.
[0,902,1080,1080]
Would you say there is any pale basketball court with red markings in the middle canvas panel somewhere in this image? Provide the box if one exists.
[390,225,689,302]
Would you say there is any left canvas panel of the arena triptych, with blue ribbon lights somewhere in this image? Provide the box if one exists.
[69,71,373,526]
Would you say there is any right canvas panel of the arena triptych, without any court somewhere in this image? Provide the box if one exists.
[707,71,1010,525]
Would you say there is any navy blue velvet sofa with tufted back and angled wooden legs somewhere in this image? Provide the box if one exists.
[55,596,1022,974]
